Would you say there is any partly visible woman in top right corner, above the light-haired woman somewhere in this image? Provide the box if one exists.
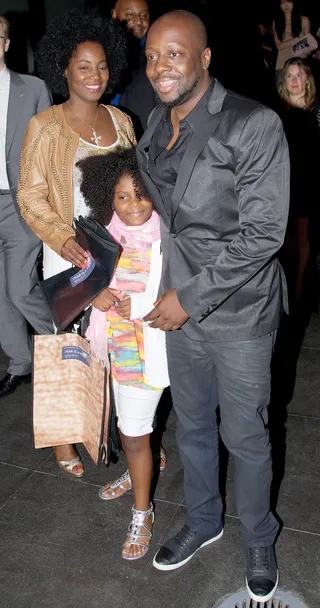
[272,0,310,70]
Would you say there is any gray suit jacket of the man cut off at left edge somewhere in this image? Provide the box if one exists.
[6,70,52,202]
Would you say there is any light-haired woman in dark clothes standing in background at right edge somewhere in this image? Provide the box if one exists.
[278,58,320,303]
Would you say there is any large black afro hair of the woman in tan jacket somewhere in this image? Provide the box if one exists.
[36,9,127,99]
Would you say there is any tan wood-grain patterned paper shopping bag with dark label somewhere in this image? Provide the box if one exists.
[33,333,112,464]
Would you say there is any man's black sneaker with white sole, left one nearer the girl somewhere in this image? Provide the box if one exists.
[153,526,223,571]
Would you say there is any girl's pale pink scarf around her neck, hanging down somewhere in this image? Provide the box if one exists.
[86,211,160,367]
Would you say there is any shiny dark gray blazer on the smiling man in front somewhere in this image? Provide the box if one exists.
[137,81,290,341]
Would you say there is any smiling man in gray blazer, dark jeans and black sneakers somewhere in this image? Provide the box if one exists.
[137,11,289,602]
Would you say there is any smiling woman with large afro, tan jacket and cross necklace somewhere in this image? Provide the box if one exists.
[18,11,135,477]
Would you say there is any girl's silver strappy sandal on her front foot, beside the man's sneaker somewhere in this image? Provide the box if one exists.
[122,503,154,561]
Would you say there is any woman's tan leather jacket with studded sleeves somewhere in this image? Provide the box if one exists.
[17,105,136,255]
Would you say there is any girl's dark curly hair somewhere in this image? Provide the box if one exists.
[77,148,151,226]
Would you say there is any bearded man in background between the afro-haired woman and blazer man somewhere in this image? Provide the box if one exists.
[111,0,156,138]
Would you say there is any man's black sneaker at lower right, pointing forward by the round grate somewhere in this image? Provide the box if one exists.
[247,546,279,603]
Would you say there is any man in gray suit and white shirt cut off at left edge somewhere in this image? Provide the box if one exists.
[0,16,53,397]
